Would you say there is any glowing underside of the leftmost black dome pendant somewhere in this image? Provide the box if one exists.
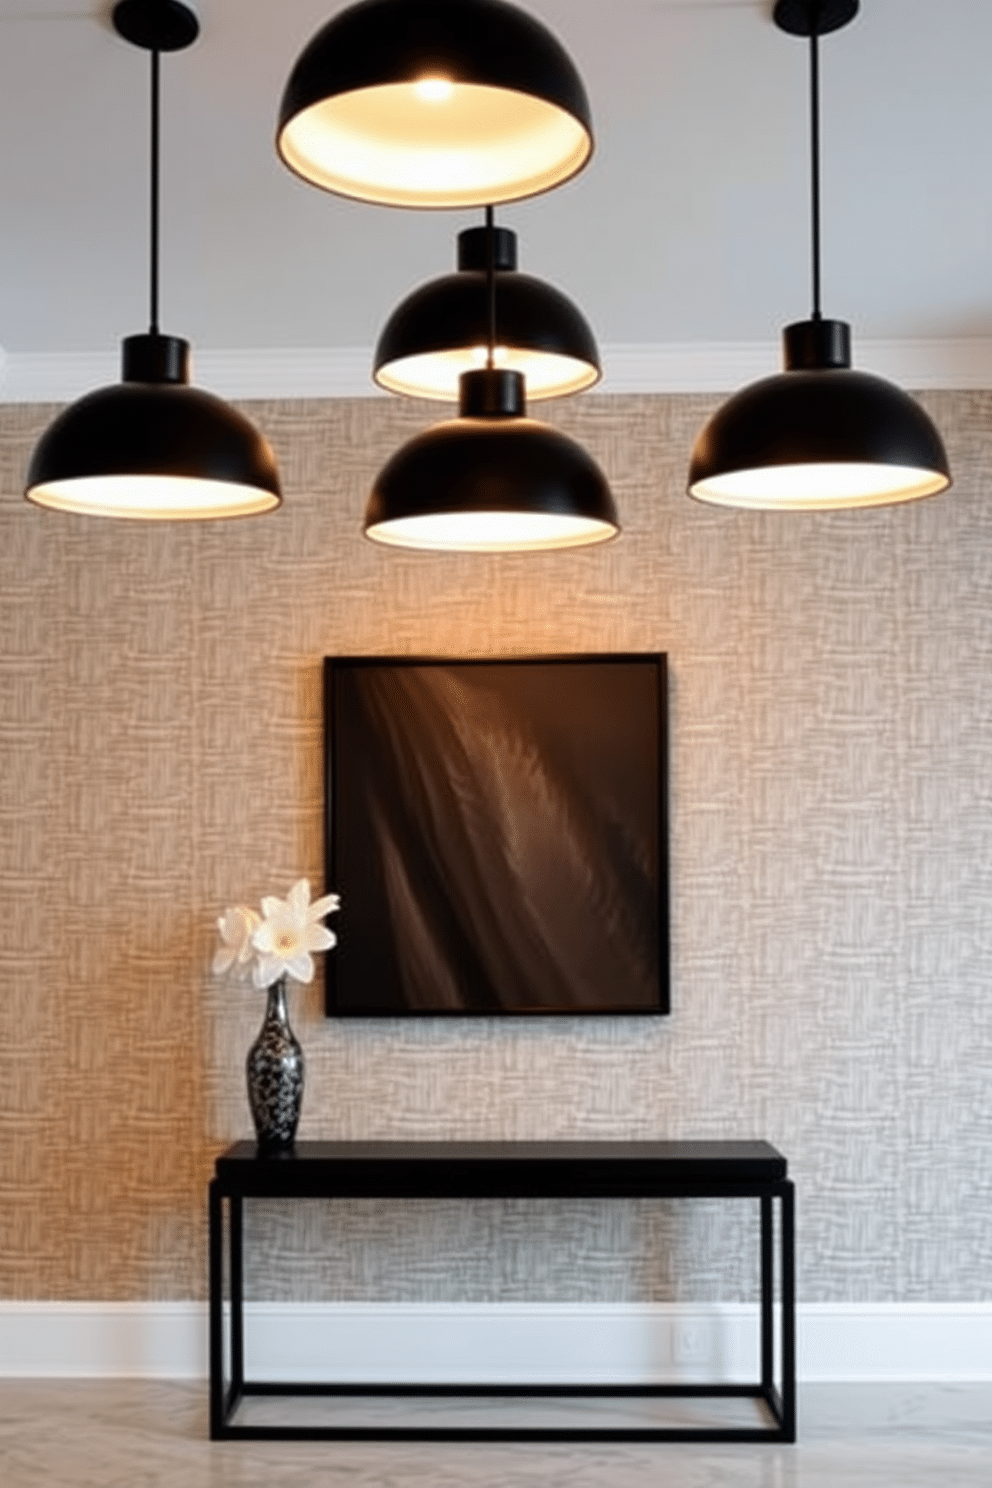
[27,475,280,522]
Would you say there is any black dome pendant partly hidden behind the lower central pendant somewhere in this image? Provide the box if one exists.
[375,215,602,402]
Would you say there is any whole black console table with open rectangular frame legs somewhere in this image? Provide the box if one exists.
[210,1141,796,1442]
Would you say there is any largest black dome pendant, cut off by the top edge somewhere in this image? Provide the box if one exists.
[277,0,592,207]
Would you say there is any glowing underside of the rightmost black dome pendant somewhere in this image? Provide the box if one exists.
[689,461,950,512]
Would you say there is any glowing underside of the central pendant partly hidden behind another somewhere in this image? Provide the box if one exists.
[375,347,599,403]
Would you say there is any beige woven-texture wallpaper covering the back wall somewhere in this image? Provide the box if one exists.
[0,393,992,1301]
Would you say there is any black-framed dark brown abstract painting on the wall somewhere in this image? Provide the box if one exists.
[324,652,671,1018]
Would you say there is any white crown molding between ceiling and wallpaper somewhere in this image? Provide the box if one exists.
[0,338,992,403]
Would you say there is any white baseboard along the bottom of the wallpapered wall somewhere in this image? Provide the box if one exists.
[0,1302,992,1384]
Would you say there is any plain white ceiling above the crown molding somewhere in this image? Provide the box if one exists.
[0,0,992,395]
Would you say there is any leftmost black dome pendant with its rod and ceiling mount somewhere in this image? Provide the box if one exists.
[25,0,281,521]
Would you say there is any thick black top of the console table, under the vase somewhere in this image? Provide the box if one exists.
[216,1141,787,1198]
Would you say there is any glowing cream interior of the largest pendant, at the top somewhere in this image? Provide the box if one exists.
[278,79,592,207]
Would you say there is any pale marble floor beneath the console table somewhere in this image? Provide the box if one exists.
[0,1379,992,1488]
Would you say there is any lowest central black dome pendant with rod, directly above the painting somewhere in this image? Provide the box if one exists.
[364,208,620,552]
